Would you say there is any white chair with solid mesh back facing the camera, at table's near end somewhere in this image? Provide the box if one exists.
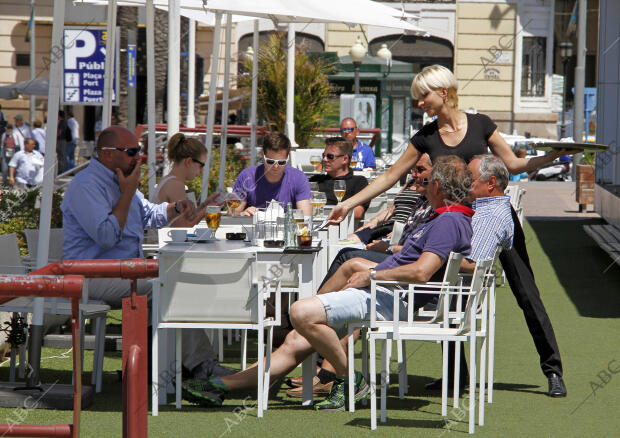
[152,251,281,417]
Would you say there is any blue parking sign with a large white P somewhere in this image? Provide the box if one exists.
[62,27,119,105]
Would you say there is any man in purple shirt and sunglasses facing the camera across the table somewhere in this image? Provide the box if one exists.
[233,132,312,216]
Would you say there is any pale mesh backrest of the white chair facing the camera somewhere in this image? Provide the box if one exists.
[158,250,263,324]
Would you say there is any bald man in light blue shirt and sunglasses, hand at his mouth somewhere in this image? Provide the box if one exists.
[60,126,201,307]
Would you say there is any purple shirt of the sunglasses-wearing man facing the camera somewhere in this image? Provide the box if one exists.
[233,164,312,208]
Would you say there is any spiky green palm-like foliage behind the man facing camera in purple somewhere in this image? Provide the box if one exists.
[240,33,334,147]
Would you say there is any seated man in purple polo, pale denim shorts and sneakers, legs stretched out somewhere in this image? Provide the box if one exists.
[178,156,473,411]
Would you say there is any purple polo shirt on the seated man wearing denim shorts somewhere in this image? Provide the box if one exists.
[375,211,472,271]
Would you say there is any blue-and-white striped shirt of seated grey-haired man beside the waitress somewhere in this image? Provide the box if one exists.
[468,196,514,262]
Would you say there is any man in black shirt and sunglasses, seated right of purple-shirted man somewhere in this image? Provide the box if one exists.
[310,137,370,219]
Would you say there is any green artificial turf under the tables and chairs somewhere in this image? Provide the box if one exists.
[0,221,620,438]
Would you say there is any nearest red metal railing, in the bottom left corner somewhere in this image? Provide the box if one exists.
[0,275,84,438]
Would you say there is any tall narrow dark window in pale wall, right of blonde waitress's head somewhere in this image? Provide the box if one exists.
[521,37,547,97]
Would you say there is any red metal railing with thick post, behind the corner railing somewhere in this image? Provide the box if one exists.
[0,259,159,438]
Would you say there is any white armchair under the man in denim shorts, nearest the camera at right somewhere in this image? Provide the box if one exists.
[368,259,493,433]
